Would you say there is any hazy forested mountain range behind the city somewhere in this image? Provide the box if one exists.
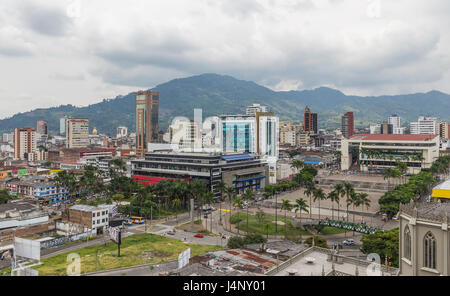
[0,74,450,134]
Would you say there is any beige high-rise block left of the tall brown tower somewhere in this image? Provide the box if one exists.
[66,118,89,148]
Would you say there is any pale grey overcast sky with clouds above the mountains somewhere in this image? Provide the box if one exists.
[0,0,450,118]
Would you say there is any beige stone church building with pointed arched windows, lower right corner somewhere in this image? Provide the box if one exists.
[399,202,450,276]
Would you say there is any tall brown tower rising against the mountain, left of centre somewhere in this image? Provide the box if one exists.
[136,91,159,157]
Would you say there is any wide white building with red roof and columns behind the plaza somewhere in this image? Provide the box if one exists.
[341,134,439,173]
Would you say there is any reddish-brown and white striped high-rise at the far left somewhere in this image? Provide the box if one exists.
[14,128,36,161]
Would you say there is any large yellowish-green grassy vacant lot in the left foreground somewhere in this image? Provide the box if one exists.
[36,233,221,276]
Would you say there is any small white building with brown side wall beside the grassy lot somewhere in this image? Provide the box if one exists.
[68,205,109,234]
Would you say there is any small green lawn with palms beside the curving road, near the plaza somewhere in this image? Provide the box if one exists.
[231,213,310,235]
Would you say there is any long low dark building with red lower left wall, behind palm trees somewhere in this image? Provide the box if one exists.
[131,152,269,193]
